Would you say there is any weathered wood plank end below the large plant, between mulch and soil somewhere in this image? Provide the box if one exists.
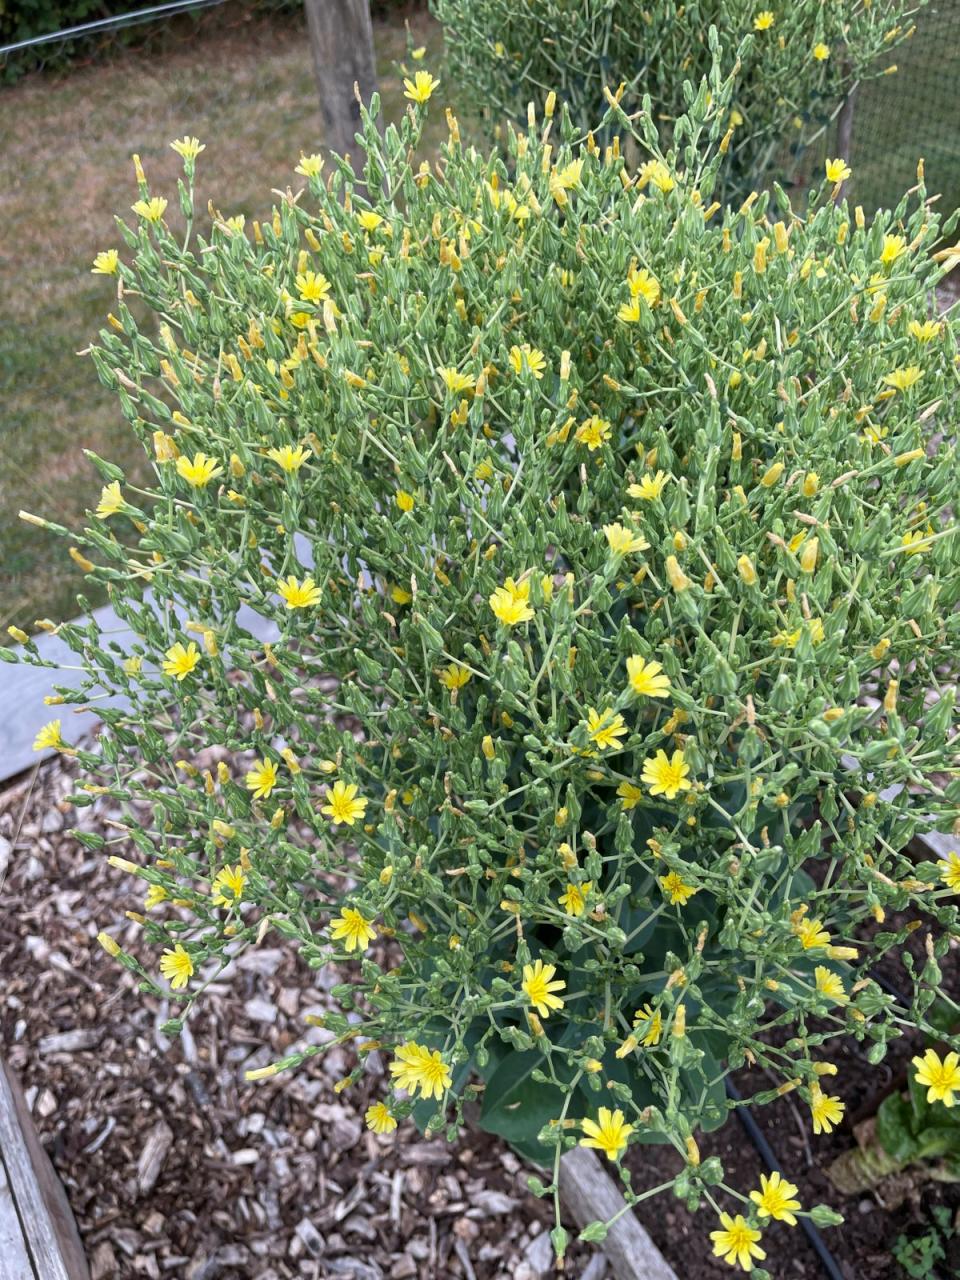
[559,1147,677,1280]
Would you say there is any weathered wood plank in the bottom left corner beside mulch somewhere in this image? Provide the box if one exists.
[0,1062,90,1280]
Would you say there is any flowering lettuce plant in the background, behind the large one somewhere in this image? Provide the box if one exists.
[431,0,925,198]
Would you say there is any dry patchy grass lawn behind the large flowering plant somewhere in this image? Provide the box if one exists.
[0,6,454,640]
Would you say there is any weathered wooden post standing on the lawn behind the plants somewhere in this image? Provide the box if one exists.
[303,0,376,168]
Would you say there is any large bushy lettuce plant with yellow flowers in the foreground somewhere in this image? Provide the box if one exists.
[13,60,960,1265]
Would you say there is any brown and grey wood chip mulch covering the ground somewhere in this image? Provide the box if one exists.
[0,760,607,1280]
